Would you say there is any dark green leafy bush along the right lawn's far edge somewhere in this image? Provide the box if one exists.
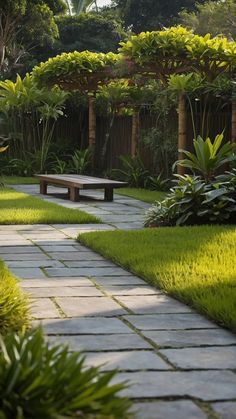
[145,173,236,227]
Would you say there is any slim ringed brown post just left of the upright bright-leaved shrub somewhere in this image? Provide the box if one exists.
[177,93,187,175]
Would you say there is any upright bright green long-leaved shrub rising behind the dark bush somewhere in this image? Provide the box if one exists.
[174,133,236,182]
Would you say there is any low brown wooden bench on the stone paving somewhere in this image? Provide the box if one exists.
[35,175,127,201]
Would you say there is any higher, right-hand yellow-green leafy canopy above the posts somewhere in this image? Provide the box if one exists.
[120,26,236,77]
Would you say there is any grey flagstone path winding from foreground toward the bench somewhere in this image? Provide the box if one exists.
[0,187,236,419]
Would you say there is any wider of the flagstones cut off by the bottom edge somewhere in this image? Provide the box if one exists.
[132,400,208,419]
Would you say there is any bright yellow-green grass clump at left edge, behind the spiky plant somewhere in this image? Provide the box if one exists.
[0,260,28,334]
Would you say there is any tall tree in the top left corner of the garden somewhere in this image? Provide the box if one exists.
[0,0,66,77]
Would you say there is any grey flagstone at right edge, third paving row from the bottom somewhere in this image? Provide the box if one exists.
[161,346,236,370]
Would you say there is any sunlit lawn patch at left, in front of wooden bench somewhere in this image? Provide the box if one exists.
[0,188,100,224]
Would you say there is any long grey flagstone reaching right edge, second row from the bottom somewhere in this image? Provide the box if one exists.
[112,371,236,401]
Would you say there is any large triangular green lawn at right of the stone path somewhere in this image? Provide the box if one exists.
[79,226,236,331]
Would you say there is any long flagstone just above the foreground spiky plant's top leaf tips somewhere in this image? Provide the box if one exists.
[37,316,132,334]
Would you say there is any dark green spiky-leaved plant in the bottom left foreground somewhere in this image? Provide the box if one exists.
[0,329,130,419]
